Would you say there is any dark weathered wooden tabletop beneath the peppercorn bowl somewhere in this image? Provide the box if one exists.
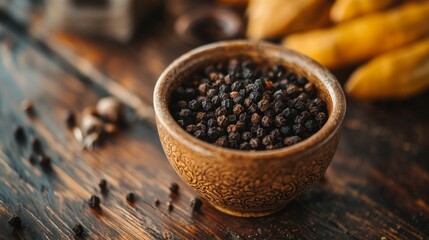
[0,7,429,239]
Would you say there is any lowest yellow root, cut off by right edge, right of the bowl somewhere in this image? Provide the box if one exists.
[345,38,429,100]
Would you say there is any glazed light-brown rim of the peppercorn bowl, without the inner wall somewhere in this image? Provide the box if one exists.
[153,40,346,160]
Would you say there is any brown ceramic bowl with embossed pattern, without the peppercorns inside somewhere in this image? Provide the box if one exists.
[154,41,346,217]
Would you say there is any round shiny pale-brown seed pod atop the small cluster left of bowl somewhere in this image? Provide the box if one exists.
[96,97,124,123]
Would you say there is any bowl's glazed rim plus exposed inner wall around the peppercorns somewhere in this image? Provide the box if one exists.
[154,41,345,157]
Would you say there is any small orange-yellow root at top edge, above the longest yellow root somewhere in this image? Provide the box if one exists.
[330,0,398,22]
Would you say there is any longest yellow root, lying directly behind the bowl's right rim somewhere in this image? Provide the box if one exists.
[283,1,429,68]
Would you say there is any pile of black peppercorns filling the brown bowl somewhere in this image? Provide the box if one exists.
[169,58,328,150]
